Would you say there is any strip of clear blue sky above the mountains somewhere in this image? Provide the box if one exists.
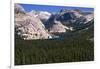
[20,4,94,12]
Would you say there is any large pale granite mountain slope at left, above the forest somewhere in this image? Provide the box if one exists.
[15,4,51,40]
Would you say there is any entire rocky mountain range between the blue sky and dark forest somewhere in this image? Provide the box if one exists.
[14,4,94,40]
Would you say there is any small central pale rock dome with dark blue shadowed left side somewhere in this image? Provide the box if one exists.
[45,15,70,33]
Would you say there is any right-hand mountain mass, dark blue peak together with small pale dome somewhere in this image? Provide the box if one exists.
[45,9,94,33]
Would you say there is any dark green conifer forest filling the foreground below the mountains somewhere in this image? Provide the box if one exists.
[15,23,94,65]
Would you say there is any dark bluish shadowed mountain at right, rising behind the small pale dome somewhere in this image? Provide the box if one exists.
[46,9,94,31]
